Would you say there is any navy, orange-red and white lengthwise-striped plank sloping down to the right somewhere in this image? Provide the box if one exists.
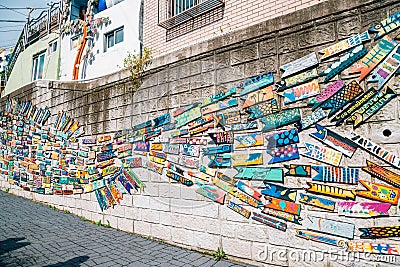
[310,124,358,158]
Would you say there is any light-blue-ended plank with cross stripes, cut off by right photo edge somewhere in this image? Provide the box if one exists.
[367,44,400,90]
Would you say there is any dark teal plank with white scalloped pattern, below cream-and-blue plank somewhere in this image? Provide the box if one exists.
[320,45,368,83]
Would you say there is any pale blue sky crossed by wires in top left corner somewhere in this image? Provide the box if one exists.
[0,0,51,49]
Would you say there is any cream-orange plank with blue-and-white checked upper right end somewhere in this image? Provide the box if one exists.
[318,31,370,60]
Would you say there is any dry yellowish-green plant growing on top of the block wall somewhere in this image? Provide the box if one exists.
[124,47,152,92]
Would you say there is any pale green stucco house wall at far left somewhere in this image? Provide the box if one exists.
[4,33,60,95]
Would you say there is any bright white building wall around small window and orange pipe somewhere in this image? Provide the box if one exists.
[60,0,141,80]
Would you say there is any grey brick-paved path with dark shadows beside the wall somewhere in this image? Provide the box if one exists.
[0,191,253,267]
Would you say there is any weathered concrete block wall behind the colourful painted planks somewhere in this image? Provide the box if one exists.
[0,0,400,267]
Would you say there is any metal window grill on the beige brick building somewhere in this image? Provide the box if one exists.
[158,0,225,30]
